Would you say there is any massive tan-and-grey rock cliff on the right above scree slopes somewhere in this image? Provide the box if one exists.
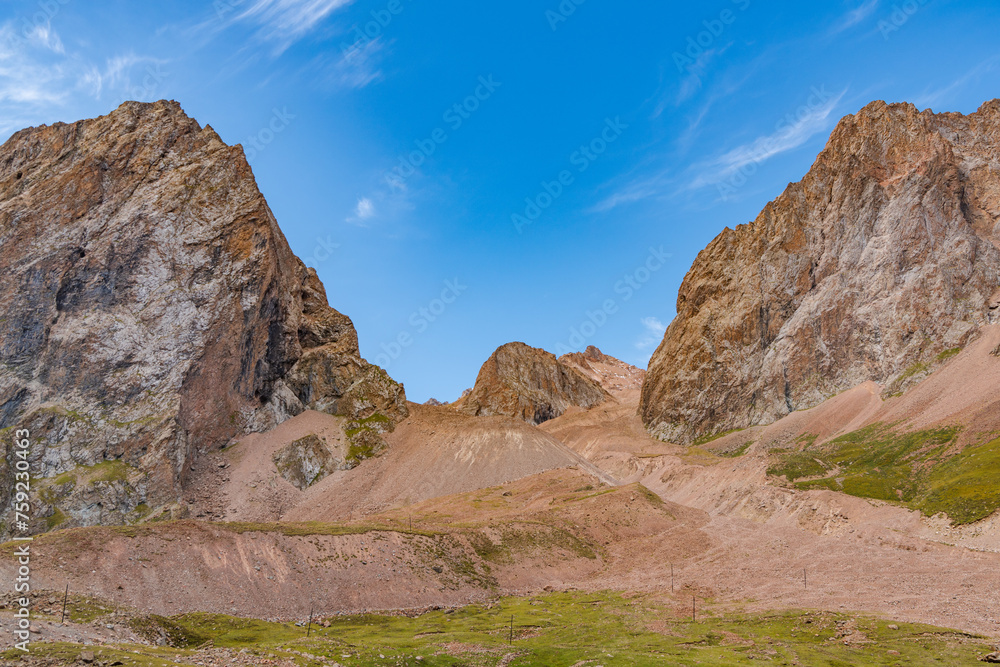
[641,101,1000,442]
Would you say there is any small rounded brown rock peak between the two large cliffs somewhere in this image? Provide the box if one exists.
[459,343,609,424]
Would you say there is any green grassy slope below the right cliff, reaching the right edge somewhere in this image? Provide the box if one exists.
[768,424,1000,525]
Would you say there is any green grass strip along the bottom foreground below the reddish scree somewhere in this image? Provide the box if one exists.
[0,592,991,667]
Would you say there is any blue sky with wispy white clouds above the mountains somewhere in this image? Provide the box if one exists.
[0,0,1000,402]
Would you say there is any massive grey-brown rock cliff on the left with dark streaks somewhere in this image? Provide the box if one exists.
[0,102,406,525]
